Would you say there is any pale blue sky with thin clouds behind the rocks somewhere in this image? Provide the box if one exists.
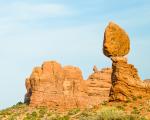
[0,0,150,109]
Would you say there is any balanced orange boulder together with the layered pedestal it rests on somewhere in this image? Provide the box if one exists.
[103,22,150,101]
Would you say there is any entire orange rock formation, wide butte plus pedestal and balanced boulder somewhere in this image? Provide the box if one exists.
[25,22,150,110]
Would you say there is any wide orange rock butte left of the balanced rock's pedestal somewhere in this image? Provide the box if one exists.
[25,61,111,110]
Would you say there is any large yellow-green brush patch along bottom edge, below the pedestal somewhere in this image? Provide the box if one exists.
[77,106,147,120]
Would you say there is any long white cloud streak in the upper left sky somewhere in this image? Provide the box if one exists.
[0,3,70,21]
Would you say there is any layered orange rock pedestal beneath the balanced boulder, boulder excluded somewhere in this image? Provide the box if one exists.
[110,57,146,101]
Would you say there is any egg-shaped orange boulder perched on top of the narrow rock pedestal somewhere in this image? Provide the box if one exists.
[103,22,130,57]
